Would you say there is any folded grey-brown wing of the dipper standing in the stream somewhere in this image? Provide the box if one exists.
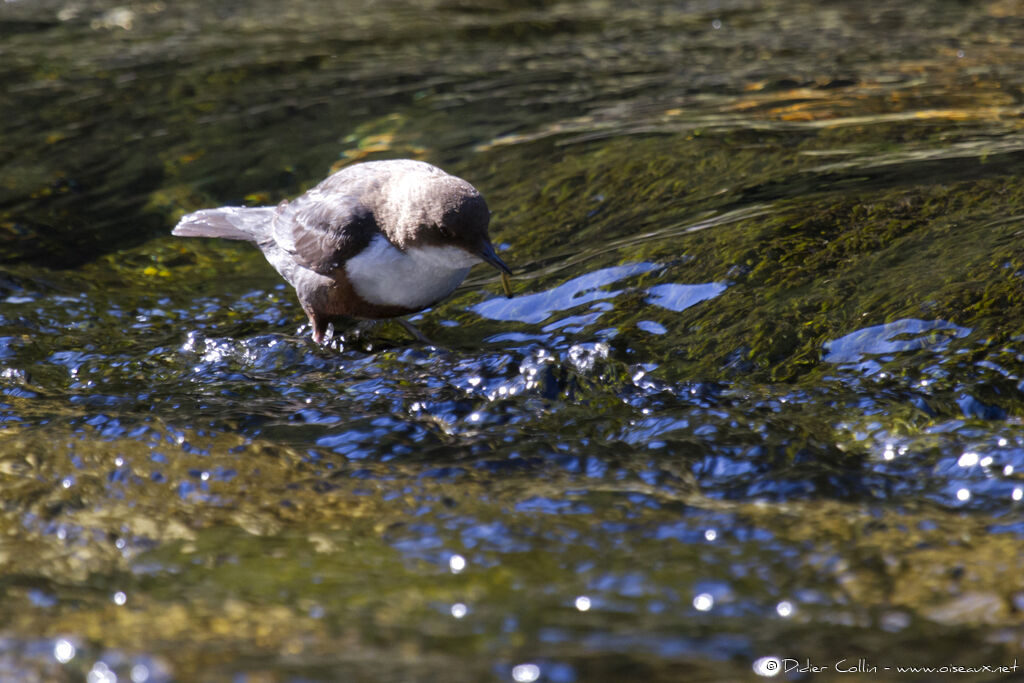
[273,191,379,275]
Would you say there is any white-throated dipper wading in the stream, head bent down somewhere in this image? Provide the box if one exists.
[173,159,520,344]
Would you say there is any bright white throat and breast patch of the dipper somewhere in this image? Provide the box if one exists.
[345,236,479,308]
